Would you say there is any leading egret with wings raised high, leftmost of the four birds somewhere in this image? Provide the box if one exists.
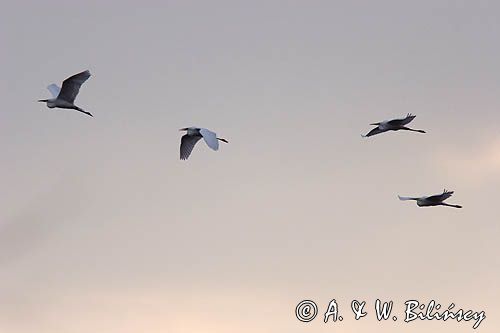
[38,70,93,117]
